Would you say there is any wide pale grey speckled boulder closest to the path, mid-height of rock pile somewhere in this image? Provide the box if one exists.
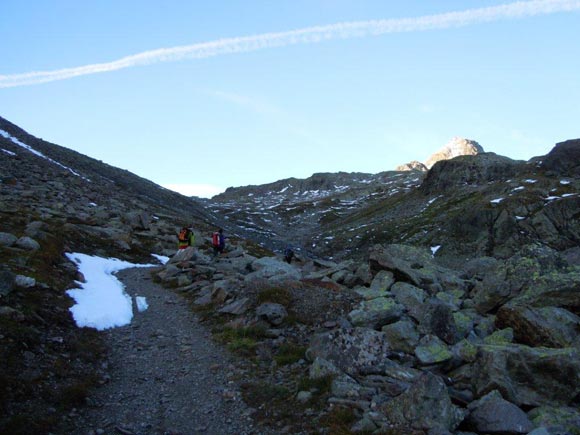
[306,328,394,376]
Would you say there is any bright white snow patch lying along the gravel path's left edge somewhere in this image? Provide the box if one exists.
[66,252,169,331]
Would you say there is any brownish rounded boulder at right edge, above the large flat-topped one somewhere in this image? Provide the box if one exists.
[495,304,580,347]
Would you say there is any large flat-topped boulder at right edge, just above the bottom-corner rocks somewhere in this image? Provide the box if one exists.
[472,344,580,406]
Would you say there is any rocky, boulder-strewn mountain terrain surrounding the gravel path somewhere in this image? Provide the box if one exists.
[0,119,580,435]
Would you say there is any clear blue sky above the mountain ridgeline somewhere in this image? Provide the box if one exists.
[0,0,580,196]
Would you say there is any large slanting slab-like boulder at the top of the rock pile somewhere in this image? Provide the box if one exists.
[369,244,466,294]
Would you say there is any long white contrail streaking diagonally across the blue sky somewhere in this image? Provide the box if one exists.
[0,0,580,88]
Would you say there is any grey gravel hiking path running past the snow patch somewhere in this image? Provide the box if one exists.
[63,269,272,435]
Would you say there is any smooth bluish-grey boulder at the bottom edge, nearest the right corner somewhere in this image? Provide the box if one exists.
[466,390,534,435]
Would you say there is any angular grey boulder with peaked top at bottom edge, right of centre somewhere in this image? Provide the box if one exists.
[379,372,465,433]
